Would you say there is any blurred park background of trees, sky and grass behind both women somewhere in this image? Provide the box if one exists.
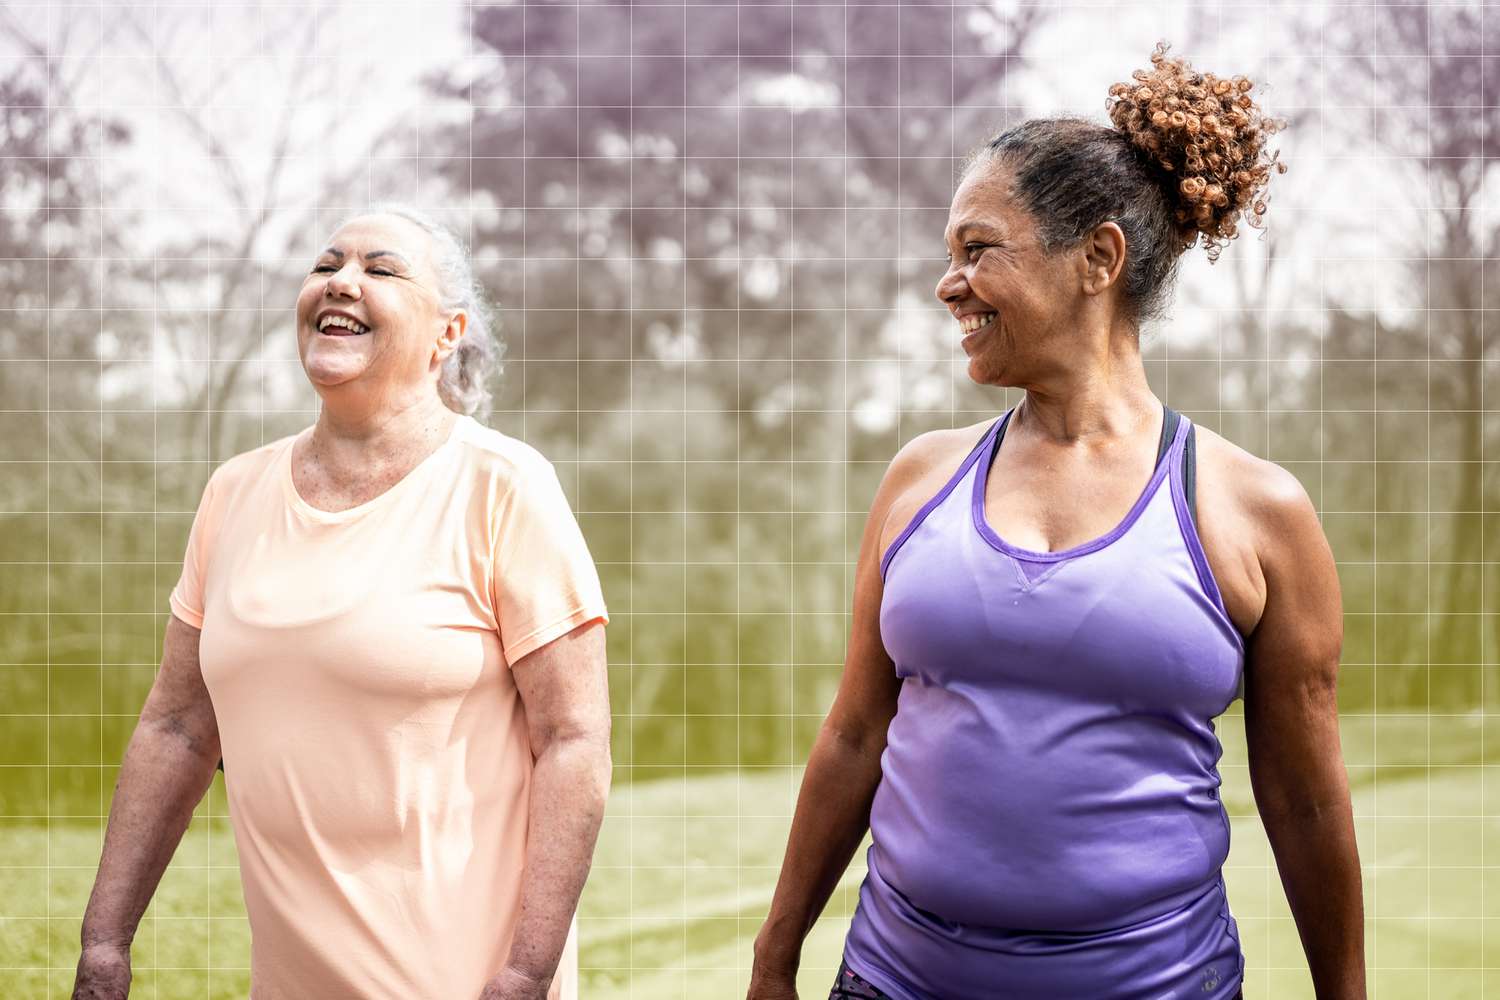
[0,1,1500,999]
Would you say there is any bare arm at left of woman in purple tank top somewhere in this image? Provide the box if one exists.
[749,435,942,1000]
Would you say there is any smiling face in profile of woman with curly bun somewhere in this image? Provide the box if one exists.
[938,163,1080,385]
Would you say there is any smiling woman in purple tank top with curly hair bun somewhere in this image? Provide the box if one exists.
[750,46,1365,1000]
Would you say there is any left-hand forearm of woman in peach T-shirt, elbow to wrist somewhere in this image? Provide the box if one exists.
[83,723,219,948]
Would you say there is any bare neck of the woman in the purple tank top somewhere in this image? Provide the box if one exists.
[1013,326,1161,444]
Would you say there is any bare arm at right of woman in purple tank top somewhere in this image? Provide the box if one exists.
[1245,469,1365,1000]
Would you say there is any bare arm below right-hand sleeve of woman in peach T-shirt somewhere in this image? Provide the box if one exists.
[482,621,611,1000]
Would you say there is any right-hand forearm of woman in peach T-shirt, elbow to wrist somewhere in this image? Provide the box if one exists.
[506,736,611,982]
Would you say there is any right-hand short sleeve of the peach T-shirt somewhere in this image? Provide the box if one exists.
[491,459,609,663]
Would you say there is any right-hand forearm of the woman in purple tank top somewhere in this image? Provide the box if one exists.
[1265,798,1365,1000]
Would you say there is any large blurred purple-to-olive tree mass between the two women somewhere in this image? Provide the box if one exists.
[431,0,1049,766]
